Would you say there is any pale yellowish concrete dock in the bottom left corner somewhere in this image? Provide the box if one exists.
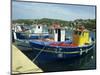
[12,45,43,74]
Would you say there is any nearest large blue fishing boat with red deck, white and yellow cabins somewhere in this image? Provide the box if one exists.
[29,23,94,62]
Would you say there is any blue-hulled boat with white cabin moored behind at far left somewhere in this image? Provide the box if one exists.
[13,24,49,40]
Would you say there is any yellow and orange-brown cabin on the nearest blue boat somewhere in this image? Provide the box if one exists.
[73,25,91,46]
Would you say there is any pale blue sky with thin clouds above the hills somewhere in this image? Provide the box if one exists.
[12,1,95,21]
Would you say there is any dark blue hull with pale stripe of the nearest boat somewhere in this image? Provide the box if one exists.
[30,42,94,63]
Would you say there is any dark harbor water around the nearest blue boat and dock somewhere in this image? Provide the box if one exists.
[15,32,96,72]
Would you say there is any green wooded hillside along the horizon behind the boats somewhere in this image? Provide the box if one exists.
[12,18,96,30]
